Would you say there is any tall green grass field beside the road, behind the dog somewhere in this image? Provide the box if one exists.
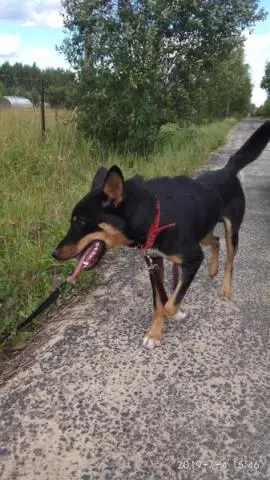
[0,110,235,338]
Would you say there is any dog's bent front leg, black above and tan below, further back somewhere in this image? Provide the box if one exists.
[164,246,203,319]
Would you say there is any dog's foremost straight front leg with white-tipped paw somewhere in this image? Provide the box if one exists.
[143,257,168,348]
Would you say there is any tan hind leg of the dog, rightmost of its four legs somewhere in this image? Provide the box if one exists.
[219,217,236,300]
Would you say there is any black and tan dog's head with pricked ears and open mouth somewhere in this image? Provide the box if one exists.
[52,166,151,271]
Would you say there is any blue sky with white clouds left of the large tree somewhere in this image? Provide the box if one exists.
[0,0,68,68]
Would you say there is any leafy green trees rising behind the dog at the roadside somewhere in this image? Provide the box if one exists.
[61,0,264,151]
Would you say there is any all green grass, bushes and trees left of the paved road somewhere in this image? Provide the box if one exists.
[0,0,265,338]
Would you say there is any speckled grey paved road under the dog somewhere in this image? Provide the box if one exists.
[0,117,270,480]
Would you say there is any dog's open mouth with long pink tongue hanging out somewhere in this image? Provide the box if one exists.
[67,240,106,282]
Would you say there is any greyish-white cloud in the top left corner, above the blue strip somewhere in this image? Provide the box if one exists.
[0,0,63,28]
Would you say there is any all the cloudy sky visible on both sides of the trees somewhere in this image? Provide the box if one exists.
[0,0,270,105]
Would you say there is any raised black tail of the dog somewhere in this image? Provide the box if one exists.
[225,121,270,175]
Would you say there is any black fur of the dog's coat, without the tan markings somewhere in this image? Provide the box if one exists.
[54,122,270,312]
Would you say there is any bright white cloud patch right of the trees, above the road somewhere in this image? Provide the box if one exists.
[245,33,270,106]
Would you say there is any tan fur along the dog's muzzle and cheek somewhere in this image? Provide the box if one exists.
[59,223,131,260]
